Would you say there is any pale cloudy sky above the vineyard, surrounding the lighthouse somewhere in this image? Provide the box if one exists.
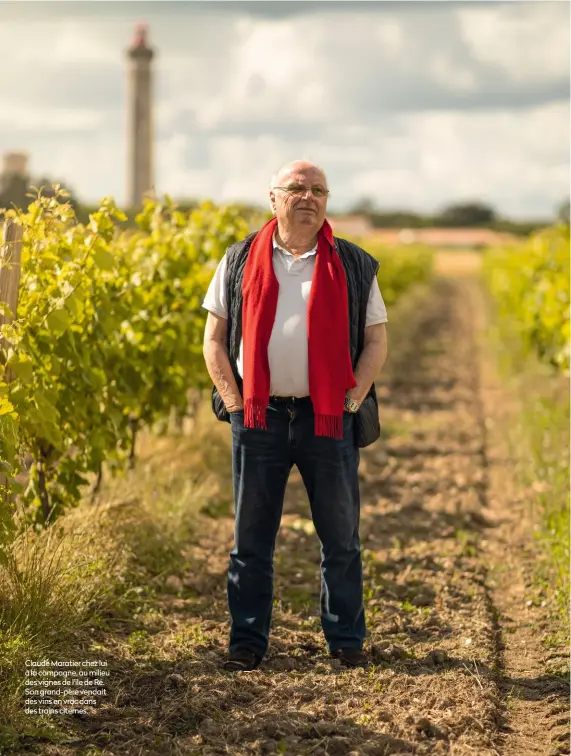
[0,0,570,219]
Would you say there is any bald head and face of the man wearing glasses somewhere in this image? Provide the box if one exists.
[270,166,327,233]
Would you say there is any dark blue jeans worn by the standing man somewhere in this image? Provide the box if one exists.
[227,397,366,656]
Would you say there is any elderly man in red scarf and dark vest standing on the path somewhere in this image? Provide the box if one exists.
[203,161,387,671]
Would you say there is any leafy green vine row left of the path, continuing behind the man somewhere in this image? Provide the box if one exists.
[0,194,432,535]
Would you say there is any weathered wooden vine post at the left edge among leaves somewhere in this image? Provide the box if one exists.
[0,221,23,504]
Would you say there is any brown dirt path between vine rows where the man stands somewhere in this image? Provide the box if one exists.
[35,277,569,756]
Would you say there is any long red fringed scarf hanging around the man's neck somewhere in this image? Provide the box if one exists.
[242,218,357,438]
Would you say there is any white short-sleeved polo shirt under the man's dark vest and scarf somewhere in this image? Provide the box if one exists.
[202,234,387,396]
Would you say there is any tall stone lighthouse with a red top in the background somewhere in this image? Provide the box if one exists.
[127,23,154,207]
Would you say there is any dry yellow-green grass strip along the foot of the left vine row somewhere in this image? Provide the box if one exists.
[0,428,232,746]
